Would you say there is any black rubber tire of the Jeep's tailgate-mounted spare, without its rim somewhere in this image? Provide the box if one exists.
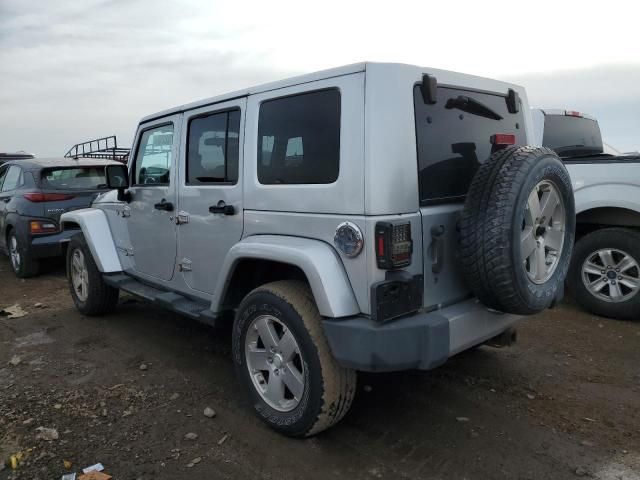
[459,146,575,315]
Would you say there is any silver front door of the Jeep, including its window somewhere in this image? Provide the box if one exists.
[126,114,181,280]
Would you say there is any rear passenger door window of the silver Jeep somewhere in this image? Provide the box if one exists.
[187,110,240,185]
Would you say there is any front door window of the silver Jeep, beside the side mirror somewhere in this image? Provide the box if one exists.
[133,124,173,186]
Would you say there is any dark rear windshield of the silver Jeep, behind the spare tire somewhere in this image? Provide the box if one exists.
[413,85,526,205]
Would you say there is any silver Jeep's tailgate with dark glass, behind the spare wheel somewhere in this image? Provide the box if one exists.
[414,85,526,308]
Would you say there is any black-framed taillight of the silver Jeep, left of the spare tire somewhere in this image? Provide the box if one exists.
[376,222,413,270]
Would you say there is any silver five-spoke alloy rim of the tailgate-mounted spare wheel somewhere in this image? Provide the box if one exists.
[520,180,566,285]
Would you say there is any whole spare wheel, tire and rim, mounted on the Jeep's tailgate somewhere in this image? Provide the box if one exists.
[460,146,575,315]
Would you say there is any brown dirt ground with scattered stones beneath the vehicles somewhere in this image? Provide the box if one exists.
[0,257,640,480]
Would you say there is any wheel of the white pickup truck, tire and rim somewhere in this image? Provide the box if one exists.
[567,228,640,320]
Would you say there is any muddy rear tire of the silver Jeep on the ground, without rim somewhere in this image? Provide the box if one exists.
[232,280,356,437]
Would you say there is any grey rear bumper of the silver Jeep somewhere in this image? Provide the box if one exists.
[323,299,521,372]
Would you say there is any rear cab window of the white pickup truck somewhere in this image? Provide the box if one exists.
[542,115,604,157]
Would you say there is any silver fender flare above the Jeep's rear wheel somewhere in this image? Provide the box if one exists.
[212,235,360,318]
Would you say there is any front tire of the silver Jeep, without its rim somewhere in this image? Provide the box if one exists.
[66,233,120,316]
